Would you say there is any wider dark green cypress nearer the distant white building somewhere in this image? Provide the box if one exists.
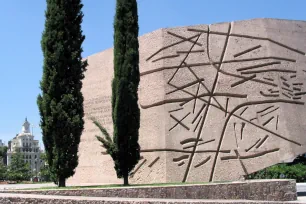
[37,0,87,187]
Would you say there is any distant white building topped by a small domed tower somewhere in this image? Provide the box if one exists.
[7,118,44,174]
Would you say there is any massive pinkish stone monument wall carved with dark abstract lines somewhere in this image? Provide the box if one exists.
[69,19,306,183]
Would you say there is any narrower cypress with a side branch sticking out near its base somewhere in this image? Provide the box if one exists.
[94,0,140,185]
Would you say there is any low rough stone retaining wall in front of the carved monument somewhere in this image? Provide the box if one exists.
[0,180,297,201]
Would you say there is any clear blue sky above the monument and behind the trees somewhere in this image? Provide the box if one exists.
[0,0,306,147]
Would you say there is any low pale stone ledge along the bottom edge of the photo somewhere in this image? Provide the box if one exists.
[0,193,306,204]
